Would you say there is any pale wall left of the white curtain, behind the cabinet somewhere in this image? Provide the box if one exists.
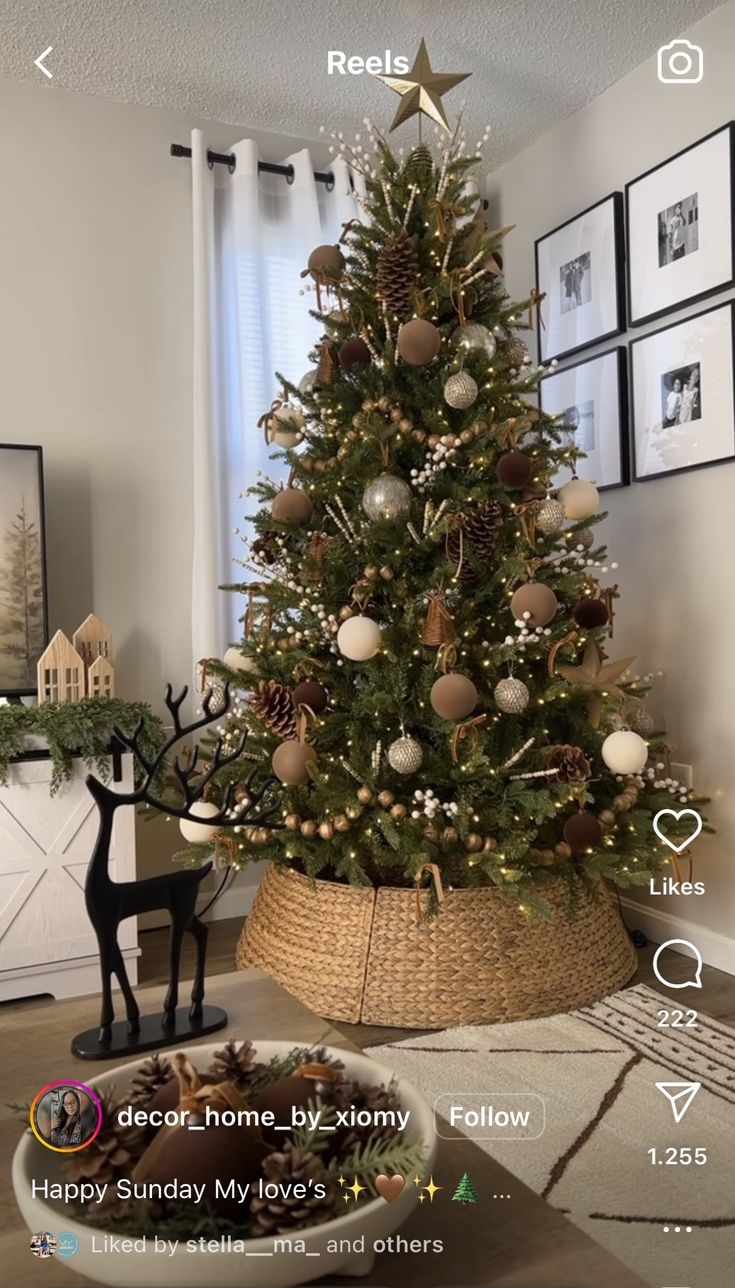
[0,77,326,907]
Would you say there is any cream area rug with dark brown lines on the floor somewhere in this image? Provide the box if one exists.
[369,985,735,1288]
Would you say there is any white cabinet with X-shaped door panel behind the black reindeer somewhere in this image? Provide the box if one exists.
[0,756,139,1001]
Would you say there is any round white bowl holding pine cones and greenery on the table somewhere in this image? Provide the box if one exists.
[13,1039,436,1288]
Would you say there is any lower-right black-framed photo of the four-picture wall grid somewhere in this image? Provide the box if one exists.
[631,303,735,480]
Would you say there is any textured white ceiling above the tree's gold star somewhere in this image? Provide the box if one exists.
[0,0,717,166]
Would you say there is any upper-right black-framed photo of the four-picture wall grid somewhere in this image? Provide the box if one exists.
[626,122,735,326]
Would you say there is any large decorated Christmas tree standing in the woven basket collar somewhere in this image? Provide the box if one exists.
[193,50,705,916]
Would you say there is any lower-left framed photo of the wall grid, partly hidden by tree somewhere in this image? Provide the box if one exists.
[539,346,629,491]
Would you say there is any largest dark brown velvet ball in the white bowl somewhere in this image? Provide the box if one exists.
[145,1128,269,1221]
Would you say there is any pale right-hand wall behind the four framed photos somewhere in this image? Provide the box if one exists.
[488,3,735,972]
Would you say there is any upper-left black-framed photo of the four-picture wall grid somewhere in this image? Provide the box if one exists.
[535,192,626,362]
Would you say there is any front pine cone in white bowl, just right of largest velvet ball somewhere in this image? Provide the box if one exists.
[250,1140,336,1239]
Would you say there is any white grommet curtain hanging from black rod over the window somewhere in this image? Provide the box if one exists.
[192,130,362,666]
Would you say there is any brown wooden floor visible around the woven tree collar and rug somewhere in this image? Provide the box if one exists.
[139,918,735,1047]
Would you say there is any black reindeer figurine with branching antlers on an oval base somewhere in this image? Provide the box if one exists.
[72,684,274,1060]
